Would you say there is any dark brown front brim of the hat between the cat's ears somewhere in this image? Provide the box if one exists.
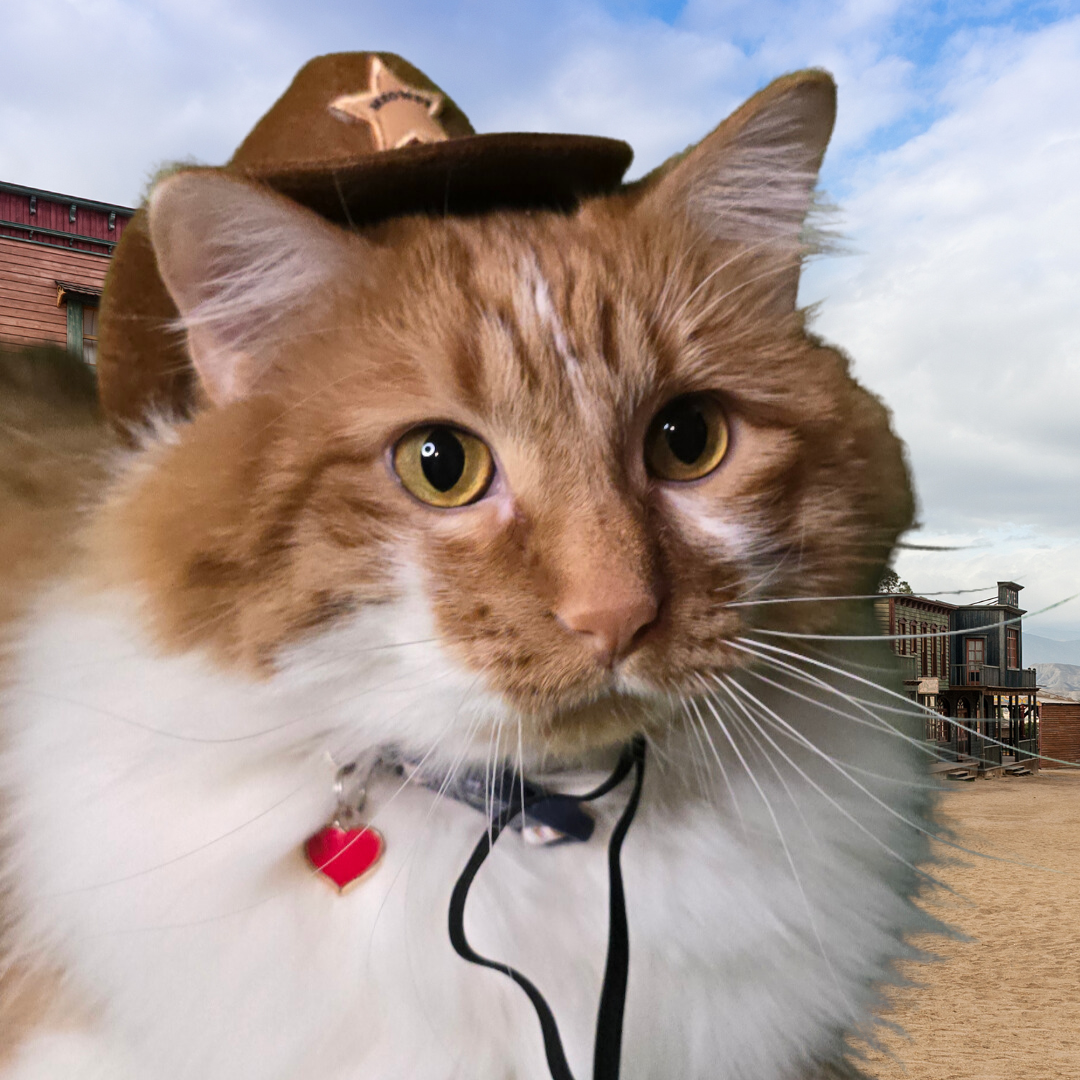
[234,133,634,226]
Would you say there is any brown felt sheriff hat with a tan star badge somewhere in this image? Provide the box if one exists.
[97,53,633,426]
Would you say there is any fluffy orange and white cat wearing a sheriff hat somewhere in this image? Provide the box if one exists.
[0,72,935,1080]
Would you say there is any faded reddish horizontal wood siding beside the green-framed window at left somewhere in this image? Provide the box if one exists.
[0,237,109,345]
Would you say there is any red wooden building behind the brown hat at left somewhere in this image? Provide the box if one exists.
[0,183,135,364]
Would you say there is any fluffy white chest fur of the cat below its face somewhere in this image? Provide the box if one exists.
[0,603,926,1080]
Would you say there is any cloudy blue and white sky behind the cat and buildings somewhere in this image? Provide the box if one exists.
[6,0,1080,637]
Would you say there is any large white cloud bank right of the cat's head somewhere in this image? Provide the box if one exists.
[805,19,1080,627]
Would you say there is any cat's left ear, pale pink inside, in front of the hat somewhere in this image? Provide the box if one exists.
[149,170,347,405]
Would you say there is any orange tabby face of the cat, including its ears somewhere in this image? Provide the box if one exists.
[97,71,910,756]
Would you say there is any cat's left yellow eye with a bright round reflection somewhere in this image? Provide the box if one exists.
[394,424,495,507]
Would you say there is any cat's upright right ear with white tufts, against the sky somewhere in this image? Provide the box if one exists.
[644,70,836,306]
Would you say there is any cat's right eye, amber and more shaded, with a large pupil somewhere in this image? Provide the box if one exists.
[645,394,728,481]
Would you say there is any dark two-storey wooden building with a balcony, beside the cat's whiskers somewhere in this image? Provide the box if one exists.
[878,581,1038,766]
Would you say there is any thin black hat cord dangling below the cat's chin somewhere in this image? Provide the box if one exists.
[449,735,645,1080]
